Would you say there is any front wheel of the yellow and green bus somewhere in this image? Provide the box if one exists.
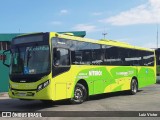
[70,83,87,104]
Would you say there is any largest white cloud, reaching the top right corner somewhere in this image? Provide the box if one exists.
[99,0,160,26]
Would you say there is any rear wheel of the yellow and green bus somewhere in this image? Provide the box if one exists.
[130,79,138,95]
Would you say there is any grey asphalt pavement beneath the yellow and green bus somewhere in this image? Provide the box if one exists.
[0,84,160,120]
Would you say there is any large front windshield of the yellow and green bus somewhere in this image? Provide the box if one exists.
[10,45,50,75]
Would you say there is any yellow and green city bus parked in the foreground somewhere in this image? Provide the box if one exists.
[3,32,156,104]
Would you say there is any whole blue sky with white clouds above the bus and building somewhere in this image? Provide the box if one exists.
[0,0,160,48]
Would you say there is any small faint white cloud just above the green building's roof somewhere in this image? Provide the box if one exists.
[73,24,98,32]
